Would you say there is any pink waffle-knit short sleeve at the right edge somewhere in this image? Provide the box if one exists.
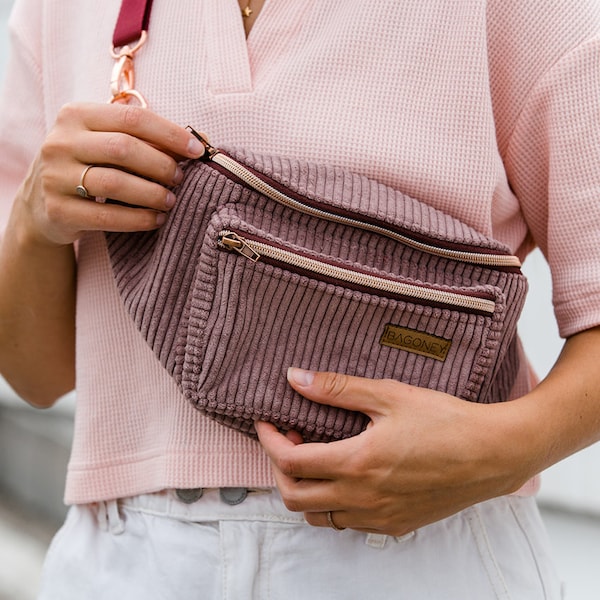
[488,0,600,337]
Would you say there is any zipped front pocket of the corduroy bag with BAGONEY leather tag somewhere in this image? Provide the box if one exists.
[182,218,505,441]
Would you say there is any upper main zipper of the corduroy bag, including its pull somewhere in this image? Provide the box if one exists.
[188,127,521,269]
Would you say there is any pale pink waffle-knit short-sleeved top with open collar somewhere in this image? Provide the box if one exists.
[0,0,600,503]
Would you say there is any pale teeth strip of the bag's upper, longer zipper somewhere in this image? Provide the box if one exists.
[211,152,521,267]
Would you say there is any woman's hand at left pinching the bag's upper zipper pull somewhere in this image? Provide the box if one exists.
[22,104,204,245]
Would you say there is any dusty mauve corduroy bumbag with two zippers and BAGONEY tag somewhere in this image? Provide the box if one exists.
[107,138,527,441]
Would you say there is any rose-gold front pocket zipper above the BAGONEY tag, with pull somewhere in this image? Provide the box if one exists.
[219,230,496,314]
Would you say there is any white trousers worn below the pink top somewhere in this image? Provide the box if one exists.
[39,490,561,600]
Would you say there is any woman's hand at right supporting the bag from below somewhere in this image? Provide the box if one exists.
[256,369,536,536]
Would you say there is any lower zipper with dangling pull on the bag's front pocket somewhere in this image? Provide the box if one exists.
[218,230,496,314]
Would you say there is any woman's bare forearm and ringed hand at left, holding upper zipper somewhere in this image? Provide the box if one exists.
[0,104,204,407]
